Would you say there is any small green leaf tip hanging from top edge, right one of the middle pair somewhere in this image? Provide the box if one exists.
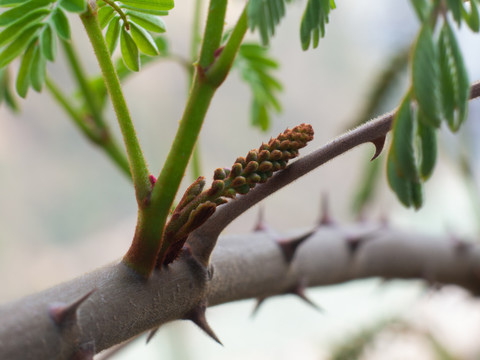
[300,0,336,50]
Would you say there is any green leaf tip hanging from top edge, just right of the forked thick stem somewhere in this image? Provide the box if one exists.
[247,0,286,45]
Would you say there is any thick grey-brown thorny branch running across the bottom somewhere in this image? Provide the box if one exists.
[0,225,480,359]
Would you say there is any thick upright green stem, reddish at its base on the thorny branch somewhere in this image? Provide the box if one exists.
[123,0,227,277]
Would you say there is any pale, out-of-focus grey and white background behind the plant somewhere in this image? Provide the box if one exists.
[0,0,480,360]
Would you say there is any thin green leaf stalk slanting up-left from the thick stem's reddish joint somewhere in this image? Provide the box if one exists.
[80,5,151,204]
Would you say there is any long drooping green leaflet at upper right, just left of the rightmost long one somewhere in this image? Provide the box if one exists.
[412,23,441,127]
